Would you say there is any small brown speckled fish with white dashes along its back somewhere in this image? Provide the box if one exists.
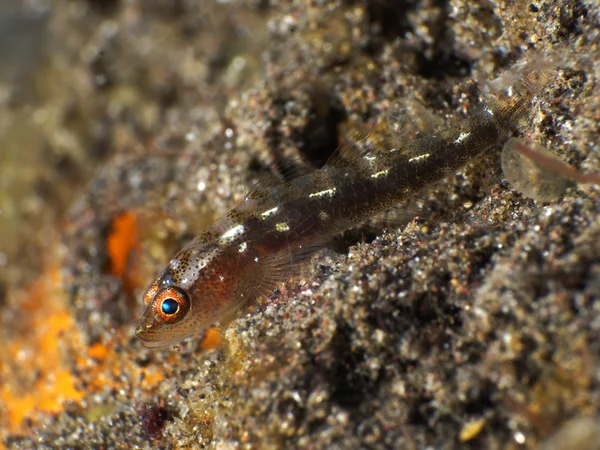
[136,72,539,348]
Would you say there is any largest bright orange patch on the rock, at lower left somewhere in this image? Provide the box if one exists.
[0,264,164,441]
